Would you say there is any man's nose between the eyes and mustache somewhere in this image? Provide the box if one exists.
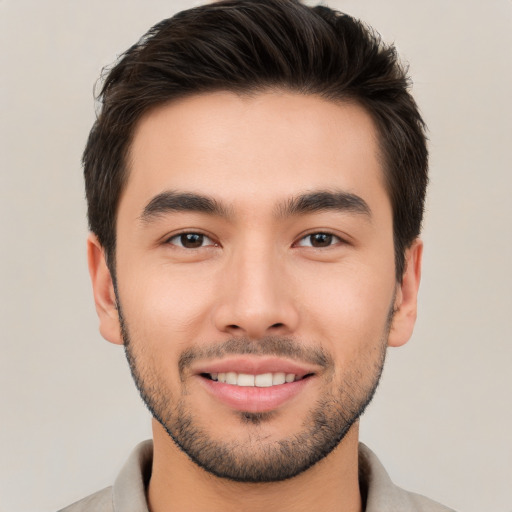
[214,244,299,339]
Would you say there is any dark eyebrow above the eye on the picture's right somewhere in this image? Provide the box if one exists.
[277,190,372,219]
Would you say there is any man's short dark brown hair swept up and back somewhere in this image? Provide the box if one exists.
[83,0,428,281]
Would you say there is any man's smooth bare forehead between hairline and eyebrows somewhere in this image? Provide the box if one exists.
[120,92,384,217]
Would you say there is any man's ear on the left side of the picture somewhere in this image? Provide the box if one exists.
[87,233,123,345]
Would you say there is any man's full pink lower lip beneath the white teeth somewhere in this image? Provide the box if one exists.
[198,376,312,412]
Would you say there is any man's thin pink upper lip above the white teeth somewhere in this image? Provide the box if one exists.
[192,356,318,377]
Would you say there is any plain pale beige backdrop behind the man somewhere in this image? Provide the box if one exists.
[0,0,512,512]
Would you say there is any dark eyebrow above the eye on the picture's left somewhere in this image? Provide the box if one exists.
[140,191,229,222]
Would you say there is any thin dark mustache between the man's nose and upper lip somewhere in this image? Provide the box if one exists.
[178,336,334,375]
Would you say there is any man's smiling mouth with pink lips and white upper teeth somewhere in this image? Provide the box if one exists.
[195,358,317,412]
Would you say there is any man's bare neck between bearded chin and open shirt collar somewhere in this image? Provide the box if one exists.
[148,420,362,512]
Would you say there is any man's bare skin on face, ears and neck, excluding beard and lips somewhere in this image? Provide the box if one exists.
[88,91,422,512]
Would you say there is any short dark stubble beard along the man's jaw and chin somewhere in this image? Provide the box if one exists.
[118,302,393,483]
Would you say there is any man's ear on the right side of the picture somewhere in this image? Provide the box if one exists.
[388,239,423,347]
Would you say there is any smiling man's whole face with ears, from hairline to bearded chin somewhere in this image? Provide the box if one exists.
[89,92,418,482]
